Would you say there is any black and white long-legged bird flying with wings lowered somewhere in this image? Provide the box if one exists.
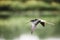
[30,19,54,34]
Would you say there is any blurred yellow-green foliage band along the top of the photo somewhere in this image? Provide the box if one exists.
[0,0,60,10]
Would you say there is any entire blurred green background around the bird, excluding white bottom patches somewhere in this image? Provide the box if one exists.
[0,0,60,40]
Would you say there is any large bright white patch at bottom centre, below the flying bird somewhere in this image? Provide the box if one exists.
[14,34,40,40]
